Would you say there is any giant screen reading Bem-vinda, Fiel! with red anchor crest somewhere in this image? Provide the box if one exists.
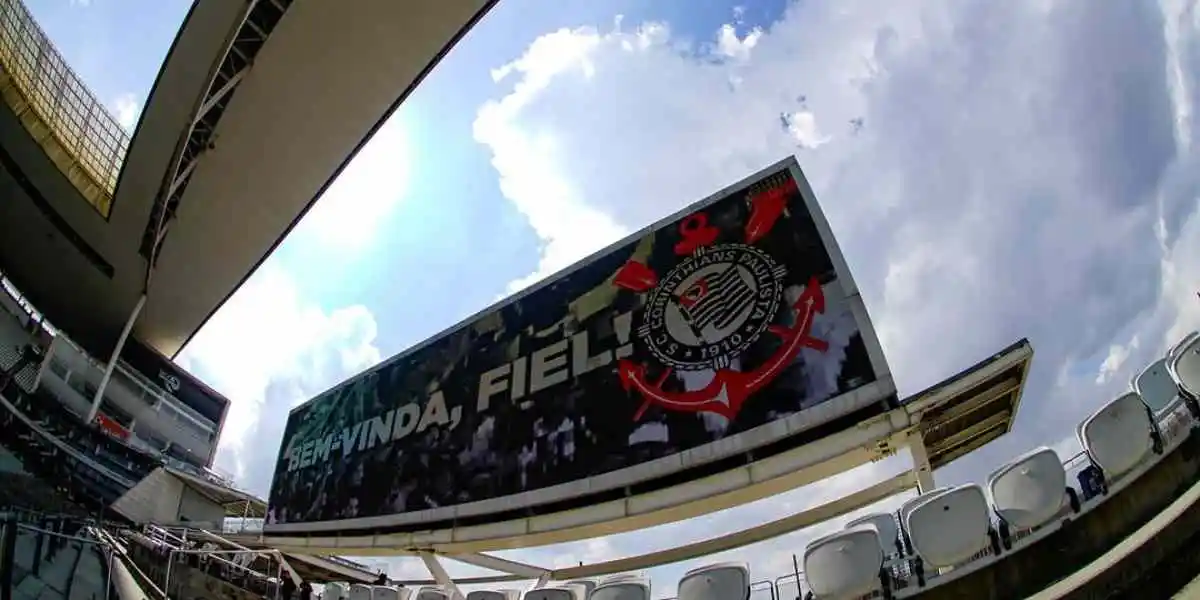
[265,160,895,533]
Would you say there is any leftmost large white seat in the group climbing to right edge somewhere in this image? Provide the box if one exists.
[804,524,883,600]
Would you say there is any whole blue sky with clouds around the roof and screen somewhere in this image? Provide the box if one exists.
[26,0,1200,595]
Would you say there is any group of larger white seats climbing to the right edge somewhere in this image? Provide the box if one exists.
[792,334,1200,600]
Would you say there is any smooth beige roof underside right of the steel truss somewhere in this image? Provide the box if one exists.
[134,0,492,356]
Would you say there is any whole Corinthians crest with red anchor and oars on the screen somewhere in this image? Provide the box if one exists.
[614,178,827,420]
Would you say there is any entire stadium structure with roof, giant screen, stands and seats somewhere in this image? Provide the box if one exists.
[0,0,1200,600]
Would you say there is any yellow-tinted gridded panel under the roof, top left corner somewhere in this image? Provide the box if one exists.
[0,0,130,218]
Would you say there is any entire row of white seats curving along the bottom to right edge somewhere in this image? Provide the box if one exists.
[405,334,1200,600]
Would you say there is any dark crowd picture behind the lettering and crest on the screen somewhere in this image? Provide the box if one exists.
[270,170,876,523]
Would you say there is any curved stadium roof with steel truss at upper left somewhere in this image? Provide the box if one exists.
[0,0,494,356]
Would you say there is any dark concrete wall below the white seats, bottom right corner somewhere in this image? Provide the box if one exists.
[916,434,1200,600]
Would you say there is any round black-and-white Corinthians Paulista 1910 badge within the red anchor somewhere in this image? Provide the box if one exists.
[637,244,786,371]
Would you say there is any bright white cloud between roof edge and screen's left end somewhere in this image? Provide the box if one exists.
[180,260,380,493]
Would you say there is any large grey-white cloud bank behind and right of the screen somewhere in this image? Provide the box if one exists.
[463,0,1200,589]
